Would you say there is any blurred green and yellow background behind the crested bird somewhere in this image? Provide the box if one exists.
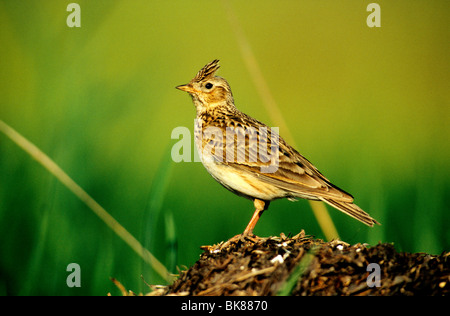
[0,0,450,295]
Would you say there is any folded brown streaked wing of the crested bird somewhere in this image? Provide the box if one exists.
[209,115,353,203]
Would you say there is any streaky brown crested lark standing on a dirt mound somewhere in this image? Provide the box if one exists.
[176,59,380,236]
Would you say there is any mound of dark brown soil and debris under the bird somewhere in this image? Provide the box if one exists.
[127,231,450,296]
